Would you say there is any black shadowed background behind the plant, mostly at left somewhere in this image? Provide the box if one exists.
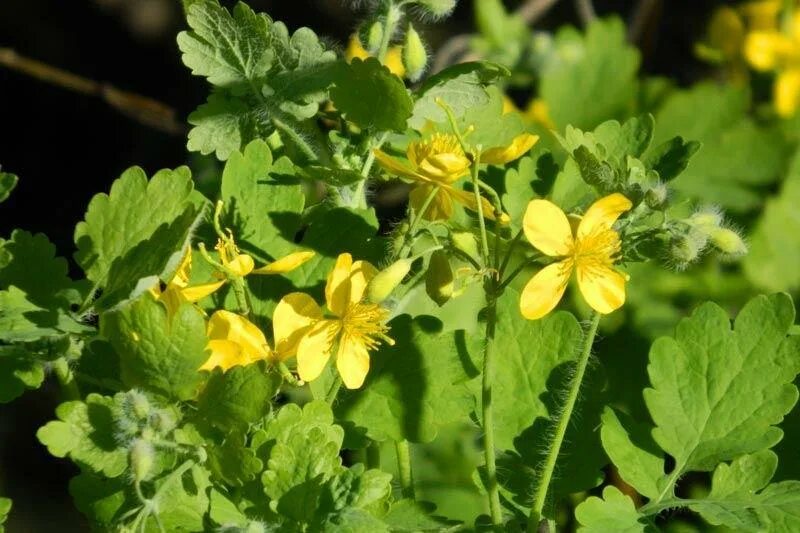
[0,0,722,533]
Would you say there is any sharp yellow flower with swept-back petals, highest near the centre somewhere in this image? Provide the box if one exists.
[374,133,539,223]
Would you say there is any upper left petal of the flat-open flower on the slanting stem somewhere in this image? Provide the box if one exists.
[522,200,573,257]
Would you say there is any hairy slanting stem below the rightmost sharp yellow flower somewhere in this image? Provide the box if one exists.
[528,311,601,531]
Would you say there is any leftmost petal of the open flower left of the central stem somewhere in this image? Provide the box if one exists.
[272,292,322,361]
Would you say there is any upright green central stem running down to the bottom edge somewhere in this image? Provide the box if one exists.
[481,294,503,531]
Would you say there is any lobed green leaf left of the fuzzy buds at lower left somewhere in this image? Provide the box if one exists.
[36,394,128,478]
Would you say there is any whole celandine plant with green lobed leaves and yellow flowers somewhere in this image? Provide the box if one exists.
[0,0,800,532]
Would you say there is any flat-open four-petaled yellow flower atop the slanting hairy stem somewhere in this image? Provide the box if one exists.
[520,193,631,320]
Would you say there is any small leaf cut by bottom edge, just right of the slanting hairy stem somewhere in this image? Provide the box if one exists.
[575,486,649,533]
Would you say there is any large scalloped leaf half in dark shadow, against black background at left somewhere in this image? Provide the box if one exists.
[75,167,200,308]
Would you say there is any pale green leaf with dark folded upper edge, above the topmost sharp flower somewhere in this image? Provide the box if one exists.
[408,61,510,130]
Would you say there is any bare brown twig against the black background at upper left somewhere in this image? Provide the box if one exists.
[0,48,186,135]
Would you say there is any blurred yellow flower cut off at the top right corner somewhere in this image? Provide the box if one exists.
[744,3,800,117]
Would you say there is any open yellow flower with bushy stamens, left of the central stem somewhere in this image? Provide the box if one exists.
[273,253,394,389]
